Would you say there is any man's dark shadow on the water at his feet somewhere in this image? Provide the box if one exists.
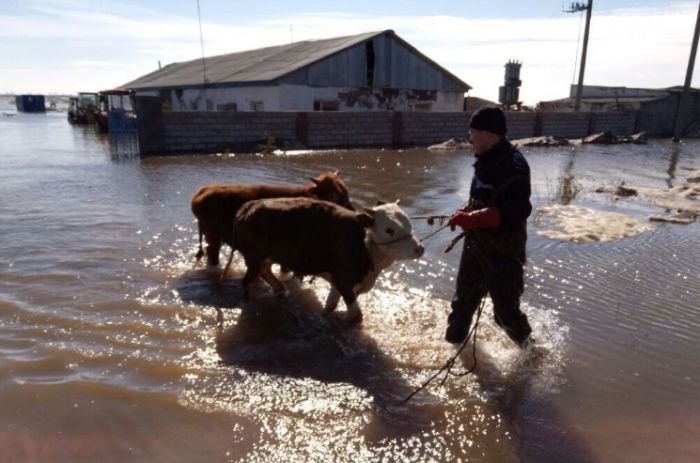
[461,346,599,463]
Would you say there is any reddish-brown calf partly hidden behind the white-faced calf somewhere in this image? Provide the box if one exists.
[192,172,352,265]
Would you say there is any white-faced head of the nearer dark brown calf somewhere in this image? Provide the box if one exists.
[357,201,425,260]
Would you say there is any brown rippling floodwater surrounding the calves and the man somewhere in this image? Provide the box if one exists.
[0,114,700,463]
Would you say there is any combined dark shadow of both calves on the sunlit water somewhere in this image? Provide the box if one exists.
[178,268,444,442]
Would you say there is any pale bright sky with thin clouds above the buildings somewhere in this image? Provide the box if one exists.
[0,0,700,105]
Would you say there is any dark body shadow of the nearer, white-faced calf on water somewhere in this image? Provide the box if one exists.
[216,281,438,400]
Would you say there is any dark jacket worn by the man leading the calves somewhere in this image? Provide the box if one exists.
[465,138,532,262]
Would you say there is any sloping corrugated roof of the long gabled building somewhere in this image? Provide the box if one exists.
[121,30,470,89]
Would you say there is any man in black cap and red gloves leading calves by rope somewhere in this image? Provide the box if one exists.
[445,107,532,347]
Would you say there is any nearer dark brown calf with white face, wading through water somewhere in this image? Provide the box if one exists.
[229,198,424,322]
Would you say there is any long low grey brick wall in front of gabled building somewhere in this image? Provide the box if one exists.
[139,97,656,154]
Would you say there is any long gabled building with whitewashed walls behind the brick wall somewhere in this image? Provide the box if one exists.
[123,30,471,112]
